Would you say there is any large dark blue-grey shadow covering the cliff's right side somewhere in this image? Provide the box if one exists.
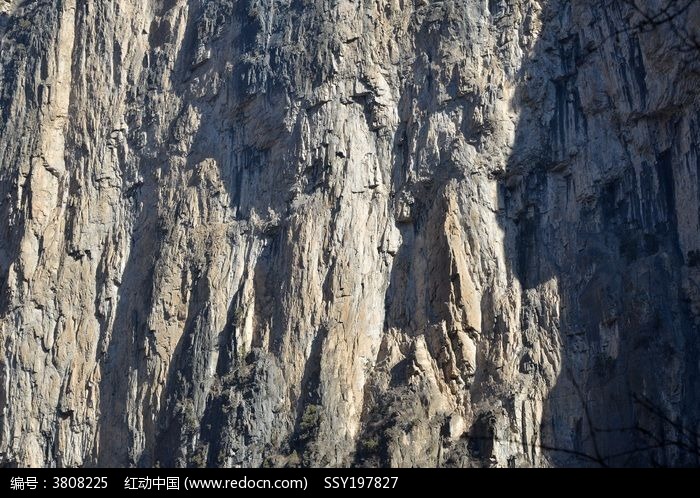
[500,1,700,466]
